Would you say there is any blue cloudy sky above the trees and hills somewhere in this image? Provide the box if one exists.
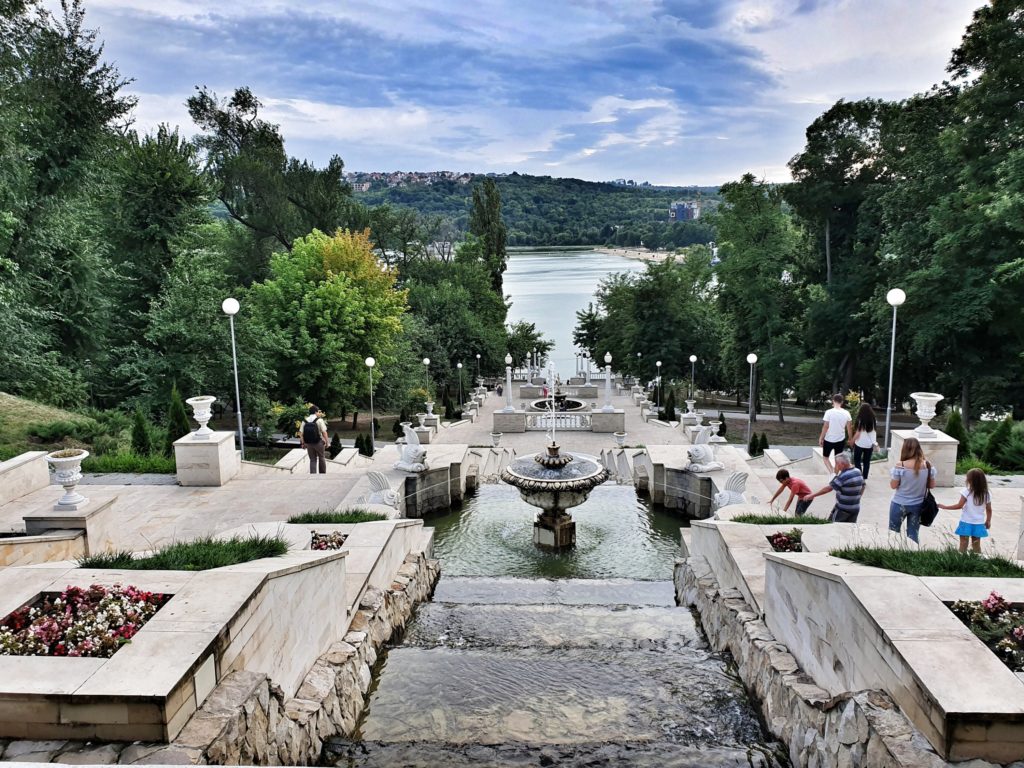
[70,0,980,185]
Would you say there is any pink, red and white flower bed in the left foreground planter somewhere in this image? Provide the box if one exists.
[0,584,170,658]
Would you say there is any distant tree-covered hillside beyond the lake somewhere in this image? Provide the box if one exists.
[356,173,719,246]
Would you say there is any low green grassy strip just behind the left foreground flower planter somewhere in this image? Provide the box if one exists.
[78,536,288,570]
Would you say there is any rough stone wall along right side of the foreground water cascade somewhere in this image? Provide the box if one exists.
[675,556,1007,768]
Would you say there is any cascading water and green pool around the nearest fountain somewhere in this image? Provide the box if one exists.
[325,485,785,768]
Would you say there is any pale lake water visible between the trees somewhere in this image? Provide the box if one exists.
[504,251,645,379]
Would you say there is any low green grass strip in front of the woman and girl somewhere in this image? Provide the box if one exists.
[828,547,1024,579]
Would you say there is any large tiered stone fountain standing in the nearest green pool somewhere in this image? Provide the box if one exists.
[502,439,609,552]
